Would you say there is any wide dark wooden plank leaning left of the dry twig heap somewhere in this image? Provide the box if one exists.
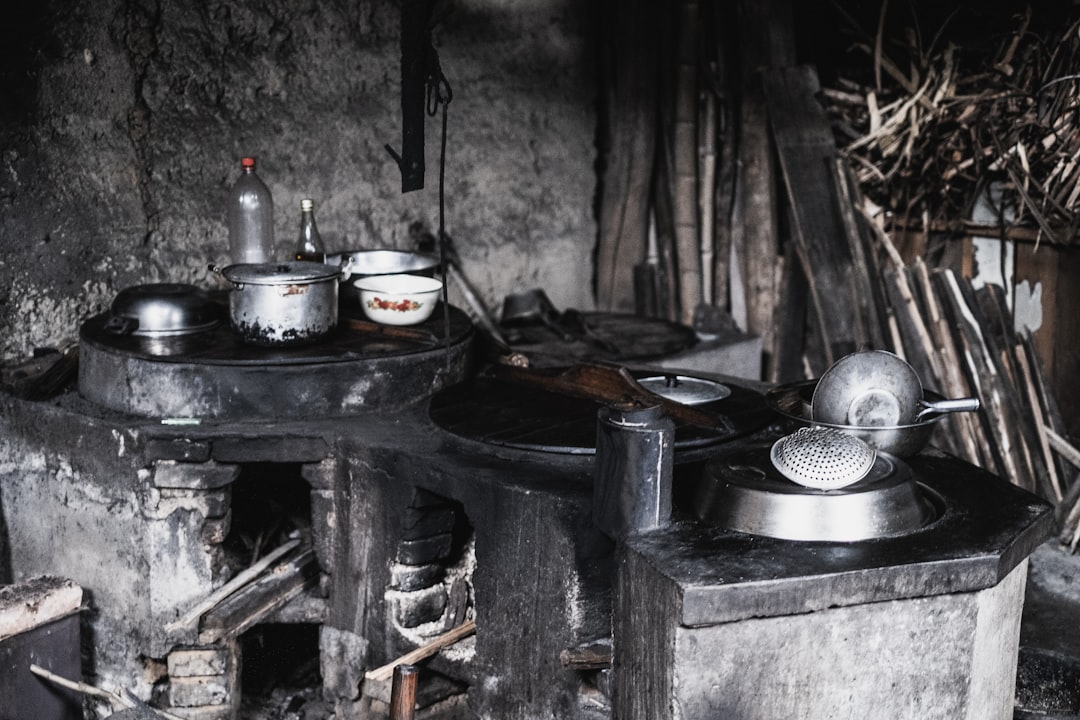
[765,66,862,370]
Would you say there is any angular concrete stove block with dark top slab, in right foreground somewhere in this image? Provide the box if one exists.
[612,453,1052,720]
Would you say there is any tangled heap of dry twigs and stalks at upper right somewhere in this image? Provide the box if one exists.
[825,2,1080,243]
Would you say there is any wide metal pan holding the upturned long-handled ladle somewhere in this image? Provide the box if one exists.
[765,380,945,458]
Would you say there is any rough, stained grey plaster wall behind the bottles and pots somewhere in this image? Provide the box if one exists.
[0,0,595,357]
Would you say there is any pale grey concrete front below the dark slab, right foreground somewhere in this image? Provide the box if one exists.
[669,561,1027,720]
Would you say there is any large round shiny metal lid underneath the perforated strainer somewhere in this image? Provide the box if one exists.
[693,446,944,542]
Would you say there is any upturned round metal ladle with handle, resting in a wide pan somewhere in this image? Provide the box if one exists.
[811,350,978,427]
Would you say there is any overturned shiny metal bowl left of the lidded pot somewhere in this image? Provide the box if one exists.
[105,283,219,337]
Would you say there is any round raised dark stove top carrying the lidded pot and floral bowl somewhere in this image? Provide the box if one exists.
[79,302,474,419]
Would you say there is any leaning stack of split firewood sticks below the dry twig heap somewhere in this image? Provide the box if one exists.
[866,208,1080,551]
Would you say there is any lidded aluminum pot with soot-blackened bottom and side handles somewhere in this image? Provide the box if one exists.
[211,262,341,347]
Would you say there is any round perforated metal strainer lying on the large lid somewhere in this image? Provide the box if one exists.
[769,427,877,490]
